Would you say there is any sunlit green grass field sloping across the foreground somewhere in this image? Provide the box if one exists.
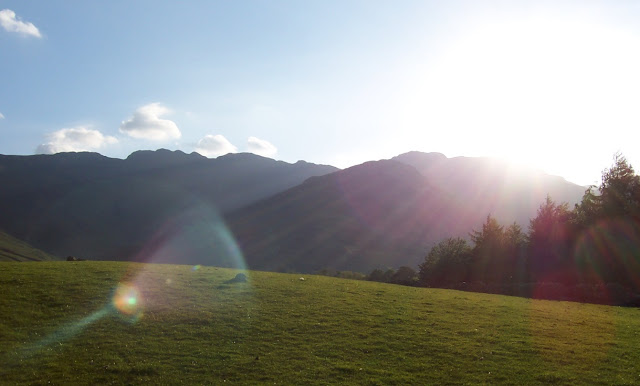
[0,262,640,385]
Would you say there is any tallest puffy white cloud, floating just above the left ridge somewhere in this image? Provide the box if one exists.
[120,103,182,141]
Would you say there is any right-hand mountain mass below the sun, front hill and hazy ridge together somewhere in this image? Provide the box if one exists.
[228,153,584,272]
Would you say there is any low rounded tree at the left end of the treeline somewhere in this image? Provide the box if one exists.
[418,237,471,286]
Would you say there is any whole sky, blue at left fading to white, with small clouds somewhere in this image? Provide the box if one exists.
[0,0,640,185]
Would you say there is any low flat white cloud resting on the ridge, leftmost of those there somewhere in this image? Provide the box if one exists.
[36,126,118,154]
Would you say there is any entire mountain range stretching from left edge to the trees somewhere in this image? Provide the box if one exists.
[0,150,584,272]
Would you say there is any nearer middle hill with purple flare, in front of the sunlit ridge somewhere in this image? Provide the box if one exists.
[228,161,477,272]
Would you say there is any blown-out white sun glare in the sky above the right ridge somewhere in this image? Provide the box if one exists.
[400,14,640,184]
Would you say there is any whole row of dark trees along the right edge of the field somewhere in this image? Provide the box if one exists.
[418,154,640,305]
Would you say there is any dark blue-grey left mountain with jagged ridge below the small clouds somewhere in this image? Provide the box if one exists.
[0,149,338,261]
